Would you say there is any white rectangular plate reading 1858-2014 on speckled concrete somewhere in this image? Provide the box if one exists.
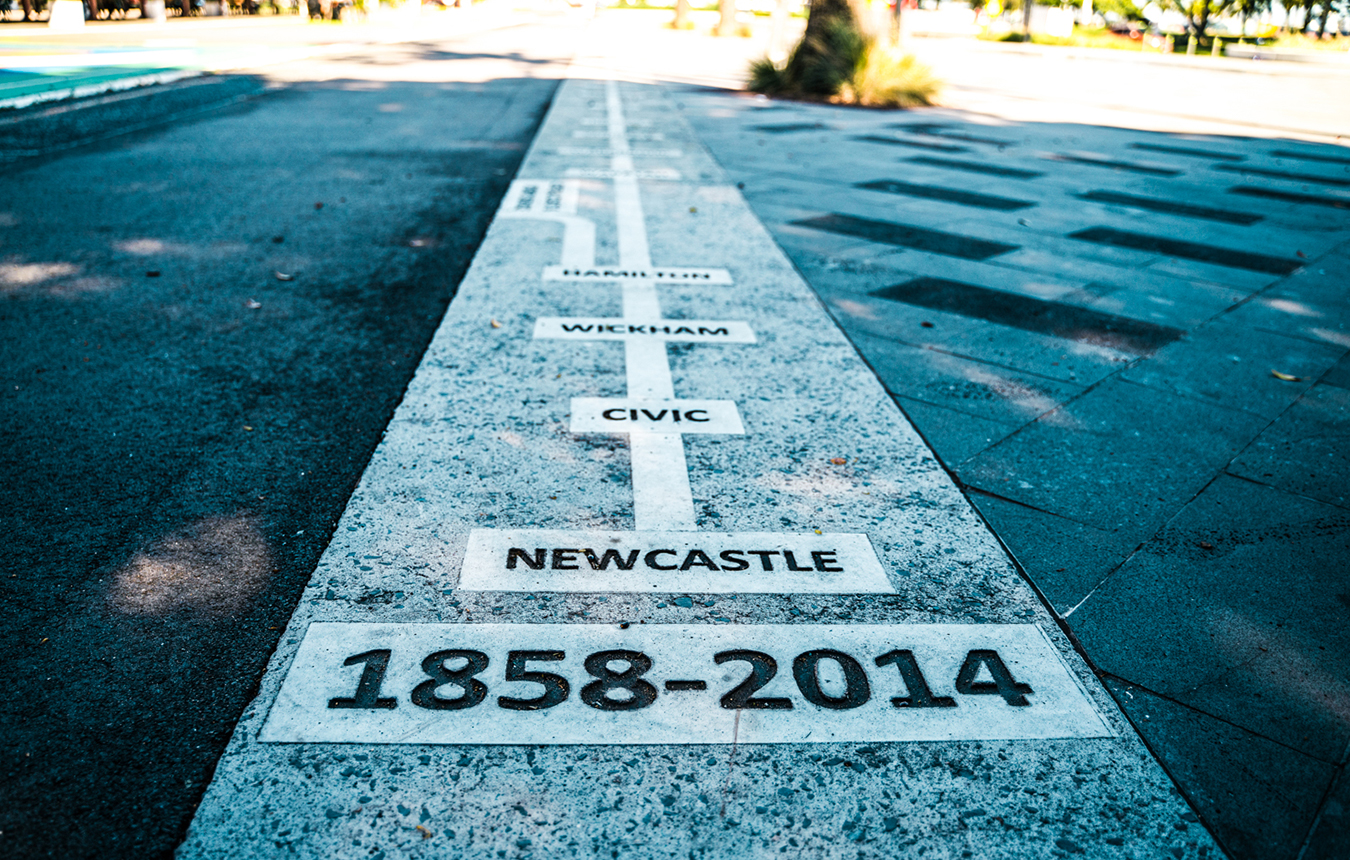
[262,622,1112,744]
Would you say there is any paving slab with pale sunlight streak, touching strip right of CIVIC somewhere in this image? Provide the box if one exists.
[852,332,1083,426]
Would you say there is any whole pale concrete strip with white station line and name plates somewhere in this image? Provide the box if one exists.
[178,70,1219,860]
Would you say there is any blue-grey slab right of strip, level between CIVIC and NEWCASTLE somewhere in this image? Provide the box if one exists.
[961,378,1266,537]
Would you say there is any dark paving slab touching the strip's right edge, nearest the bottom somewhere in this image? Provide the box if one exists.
[1103,678,1334,860]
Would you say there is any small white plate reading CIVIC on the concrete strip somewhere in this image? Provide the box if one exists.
[571,397,745,436]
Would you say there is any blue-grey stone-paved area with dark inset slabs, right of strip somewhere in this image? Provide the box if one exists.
[680,62,1350,860]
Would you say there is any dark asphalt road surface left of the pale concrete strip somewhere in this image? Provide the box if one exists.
[0,22,571,857]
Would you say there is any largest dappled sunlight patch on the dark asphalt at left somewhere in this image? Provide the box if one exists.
[108,514,273,616]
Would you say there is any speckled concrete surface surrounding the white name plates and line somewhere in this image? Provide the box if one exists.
[180,80,1219,860]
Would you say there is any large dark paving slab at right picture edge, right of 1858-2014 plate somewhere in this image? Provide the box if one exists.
[1069,475,1350,763]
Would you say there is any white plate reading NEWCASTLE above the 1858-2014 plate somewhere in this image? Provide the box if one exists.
[459,529,895,594]
